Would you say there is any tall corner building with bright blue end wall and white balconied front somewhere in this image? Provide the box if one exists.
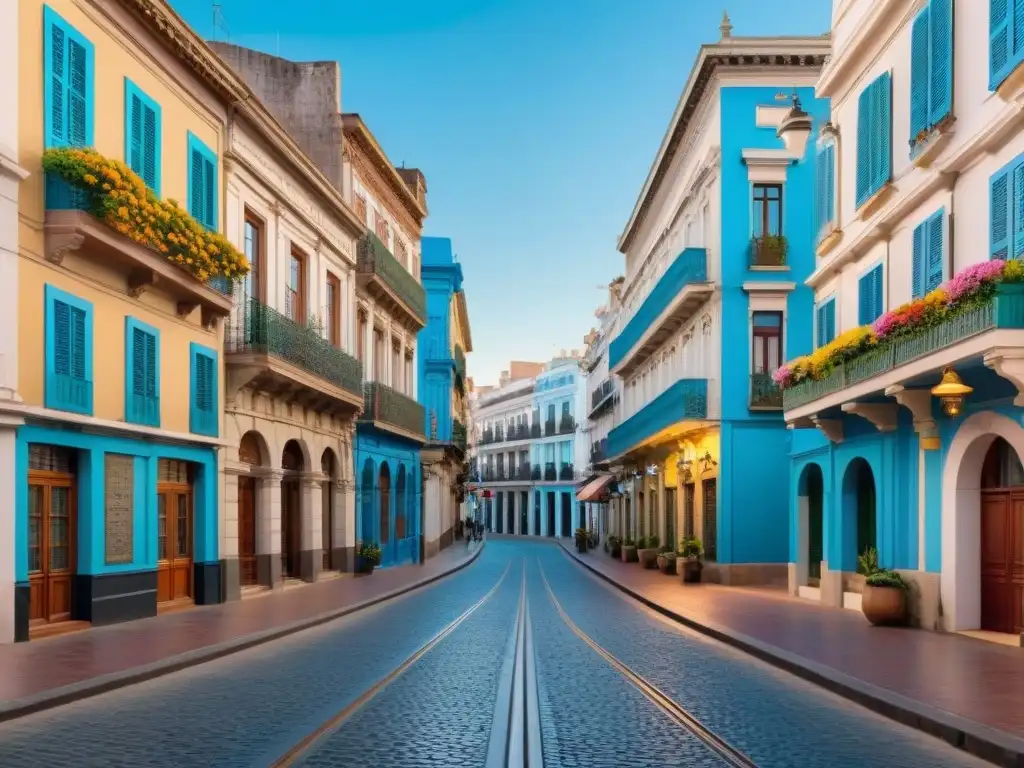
[607,27,829,584]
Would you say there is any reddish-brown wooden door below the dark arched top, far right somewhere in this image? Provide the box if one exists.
[981,492,1024,633]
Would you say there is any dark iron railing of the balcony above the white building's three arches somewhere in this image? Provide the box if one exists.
[224,298,364,399]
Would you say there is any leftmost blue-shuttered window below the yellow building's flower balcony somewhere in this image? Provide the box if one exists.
[44,286,92,416]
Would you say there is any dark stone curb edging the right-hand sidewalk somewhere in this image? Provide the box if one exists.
[561,547,1024,768]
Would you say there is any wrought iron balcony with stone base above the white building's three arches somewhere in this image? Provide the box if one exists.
[224,298,364,415]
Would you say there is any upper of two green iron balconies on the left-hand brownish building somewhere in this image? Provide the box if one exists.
[355,232,427,331]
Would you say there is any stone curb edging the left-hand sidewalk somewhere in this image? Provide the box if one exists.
[0,542,485,723]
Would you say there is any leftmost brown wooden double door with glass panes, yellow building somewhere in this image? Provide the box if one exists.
[29,479,77,624]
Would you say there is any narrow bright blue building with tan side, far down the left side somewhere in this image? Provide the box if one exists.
[417,238,473,557]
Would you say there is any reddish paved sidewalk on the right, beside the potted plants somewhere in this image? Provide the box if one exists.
[562,542,1024,766]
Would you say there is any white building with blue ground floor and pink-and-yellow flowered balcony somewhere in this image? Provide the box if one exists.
[783,0,1024,633]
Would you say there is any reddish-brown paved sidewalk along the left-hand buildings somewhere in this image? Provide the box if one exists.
[0,542,483,721]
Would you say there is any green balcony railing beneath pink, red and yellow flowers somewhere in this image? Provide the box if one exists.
[782,285,1024,411]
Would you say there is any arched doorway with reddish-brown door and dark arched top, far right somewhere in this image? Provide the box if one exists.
[981,437,1024,634]
